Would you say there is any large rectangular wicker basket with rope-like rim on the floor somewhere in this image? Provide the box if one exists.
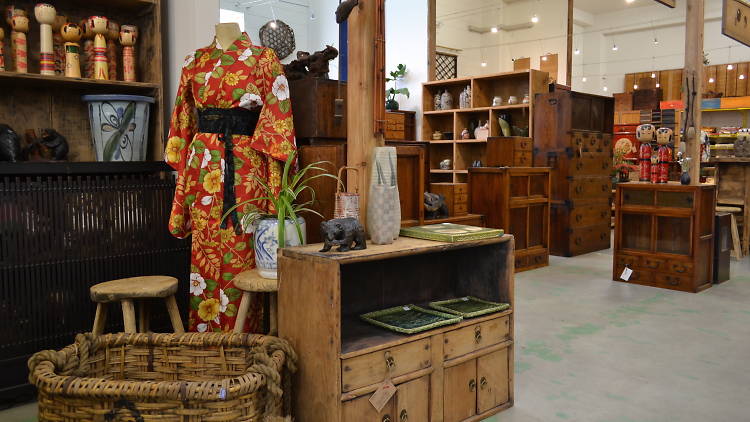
[29,333,297,422]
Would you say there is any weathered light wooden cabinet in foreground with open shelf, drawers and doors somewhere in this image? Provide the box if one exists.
[278,235,514,422]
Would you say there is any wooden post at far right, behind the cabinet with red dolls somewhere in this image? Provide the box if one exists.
[682,0,704,185]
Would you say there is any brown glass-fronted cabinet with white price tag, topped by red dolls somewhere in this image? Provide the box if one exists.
[612,182,716,293]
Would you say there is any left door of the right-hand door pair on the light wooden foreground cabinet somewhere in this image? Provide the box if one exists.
[443,360,477,422]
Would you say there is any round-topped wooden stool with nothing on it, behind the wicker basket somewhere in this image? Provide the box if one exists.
[90,275,185,336]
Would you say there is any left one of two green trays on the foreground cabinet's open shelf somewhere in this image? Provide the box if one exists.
[360,304,463,334]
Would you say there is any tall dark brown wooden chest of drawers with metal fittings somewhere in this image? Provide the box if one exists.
[534,90,614,256]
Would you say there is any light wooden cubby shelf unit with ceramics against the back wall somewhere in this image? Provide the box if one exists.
[421,70,548,183]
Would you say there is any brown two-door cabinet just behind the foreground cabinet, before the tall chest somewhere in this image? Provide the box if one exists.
[469,167,552,271]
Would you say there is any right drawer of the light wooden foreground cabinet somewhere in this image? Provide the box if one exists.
[443,315,510,360]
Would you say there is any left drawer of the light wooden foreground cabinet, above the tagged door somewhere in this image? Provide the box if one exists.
[341,338,431,392]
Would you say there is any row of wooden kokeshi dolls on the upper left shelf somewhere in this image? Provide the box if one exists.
[0,3,138,82]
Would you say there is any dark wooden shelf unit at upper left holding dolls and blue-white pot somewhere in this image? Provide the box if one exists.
[0,0,165,162]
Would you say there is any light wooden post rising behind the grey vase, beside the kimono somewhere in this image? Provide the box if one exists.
[346,1,385,227]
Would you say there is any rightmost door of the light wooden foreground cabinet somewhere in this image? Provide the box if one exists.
[477,348,510,413]
